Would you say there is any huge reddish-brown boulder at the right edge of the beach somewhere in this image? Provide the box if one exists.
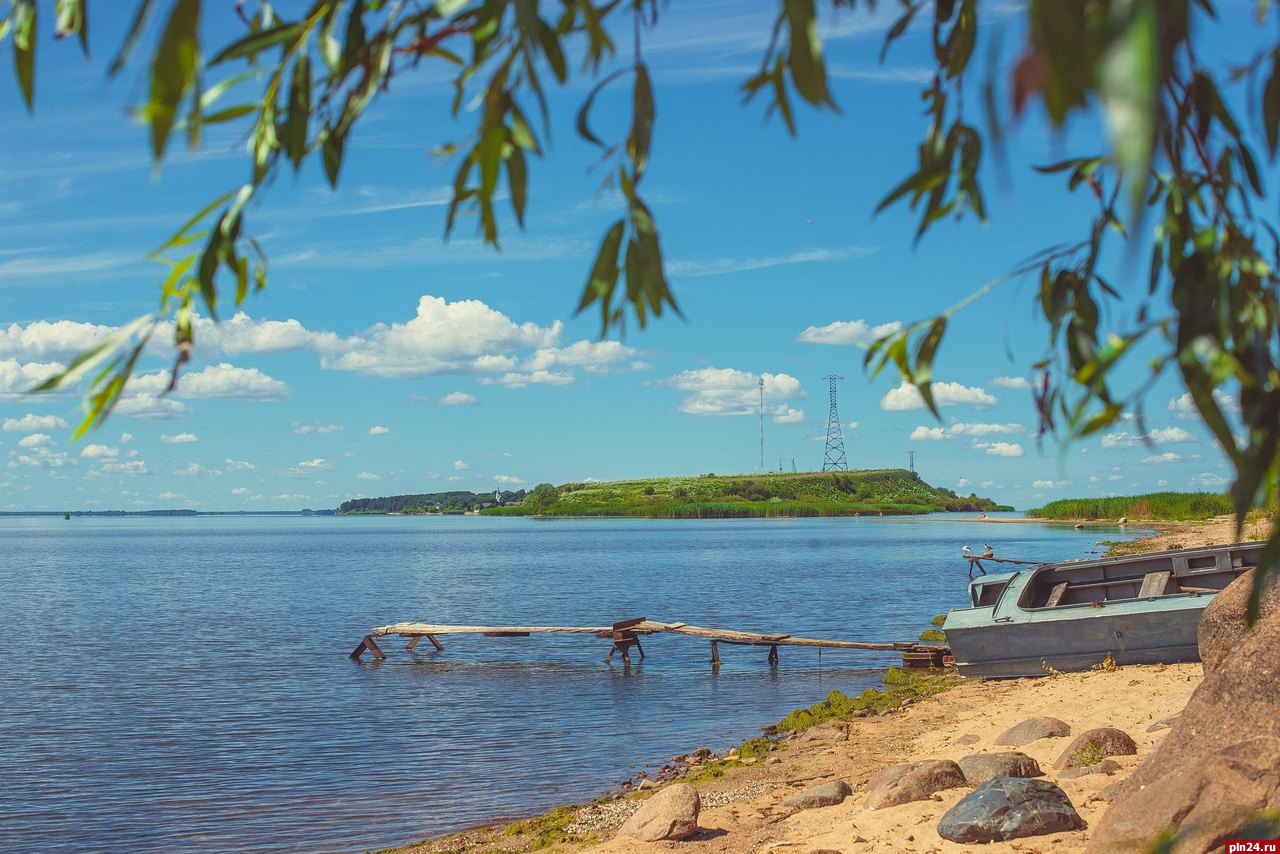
[1089,613,1280,854]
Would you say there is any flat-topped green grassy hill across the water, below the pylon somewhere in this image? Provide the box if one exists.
[484,469,1012,519]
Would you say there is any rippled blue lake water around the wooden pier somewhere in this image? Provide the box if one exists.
[0,516,1110,854]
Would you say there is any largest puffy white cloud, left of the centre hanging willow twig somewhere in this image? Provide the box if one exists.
[320,294,564,378]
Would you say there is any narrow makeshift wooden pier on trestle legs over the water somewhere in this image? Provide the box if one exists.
[351,617,951,668]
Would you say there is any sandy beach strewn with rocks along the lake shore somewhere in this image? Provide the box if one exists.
[384,517,1266,854]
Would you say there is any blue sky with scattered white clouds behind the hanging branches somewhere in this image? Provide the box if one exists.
[0,0,1259,511]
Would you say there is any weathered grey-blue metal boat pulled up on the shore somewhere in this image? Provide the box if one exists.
[942,543,1262,677]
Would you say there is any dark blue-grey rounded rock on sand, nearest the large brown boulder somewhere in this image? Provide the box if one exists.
[938,777,1085,842]
